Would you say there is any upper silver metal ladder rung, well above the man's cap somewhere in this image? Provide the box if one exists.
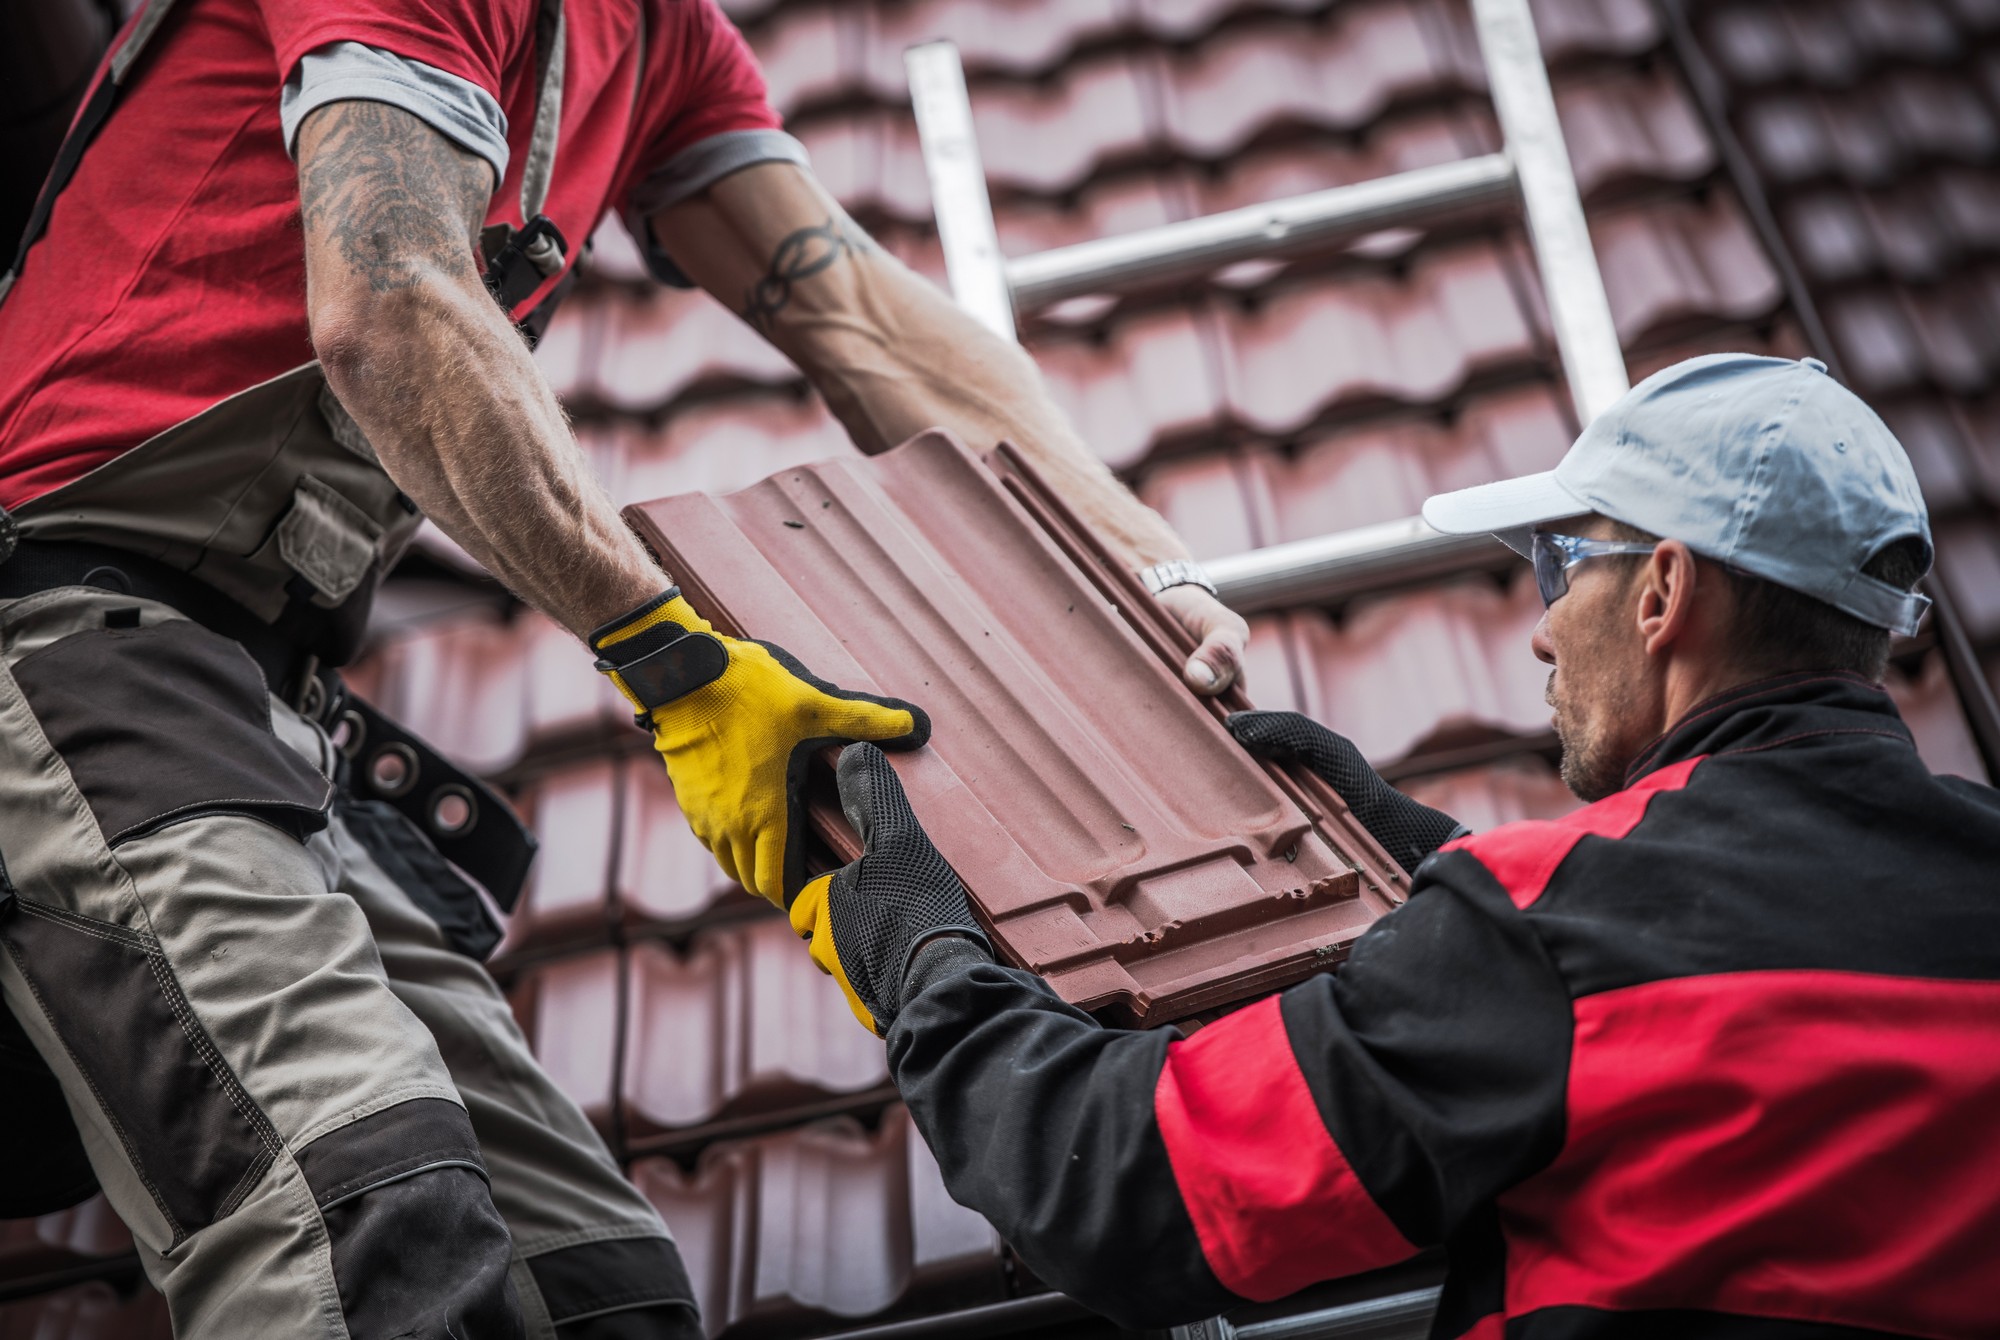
[1006,154,1518,312]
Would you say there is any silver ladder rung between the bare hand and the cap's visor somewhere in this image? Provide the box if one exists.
[1202,516,1514,614]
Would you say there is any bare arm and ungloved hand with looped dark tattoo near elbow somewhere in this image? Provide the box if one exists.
[652,162,1248,692]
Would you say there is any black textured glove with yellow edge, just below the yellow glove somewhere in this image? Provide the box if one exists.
[788,744,992,1034]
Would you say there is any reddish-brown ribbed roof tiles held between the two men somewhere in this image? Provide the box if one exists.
[626,432,1406,1024]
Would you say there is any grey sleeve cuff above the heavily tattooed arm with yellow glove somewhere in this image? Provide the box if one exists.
[278,42,508,184]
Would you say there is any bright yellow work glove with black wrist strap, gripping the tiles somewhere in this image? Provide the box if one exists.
[590,586,930,908]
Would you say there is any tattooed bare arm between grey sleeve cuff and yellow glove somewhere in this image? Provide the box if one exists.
[298,102,666,636]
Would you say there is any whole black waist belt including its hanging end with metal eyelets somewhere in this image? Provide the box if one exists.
[0,540,536,912]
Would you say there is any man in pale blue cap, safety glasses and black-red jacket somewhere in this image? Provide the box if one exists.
[802,356,2000,1340]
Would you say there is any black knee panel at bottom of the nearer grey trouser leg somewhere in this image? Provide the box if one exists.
[298,1098,522,1340]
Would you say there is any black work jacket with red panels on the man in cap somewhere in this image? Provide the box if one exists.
[890,674,2000,1340]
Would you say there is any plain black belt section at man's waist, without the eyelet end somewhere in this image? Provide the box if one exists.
[0,540,314,706]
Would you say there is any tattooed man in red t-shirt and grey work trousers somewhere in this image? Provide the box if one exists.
[0,0,1246,1340]
